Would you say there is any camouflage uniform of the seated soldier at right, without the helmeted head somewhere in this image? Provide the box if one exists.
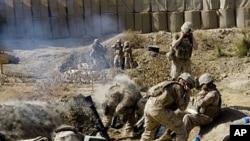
[183,87,221,132]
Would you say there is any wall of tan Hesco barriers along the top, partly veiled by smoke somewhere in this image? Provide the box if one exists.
[0,0,250,39]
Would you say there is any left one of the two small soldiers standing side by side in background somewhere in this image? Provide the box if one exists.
[112,39,124,69]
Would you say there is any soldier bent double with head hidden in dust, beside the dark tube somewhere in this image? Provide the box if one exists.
[102,78,141,135]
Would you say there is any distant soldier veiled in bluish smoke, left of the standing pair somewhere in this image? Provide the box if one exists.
[90,39,109,68]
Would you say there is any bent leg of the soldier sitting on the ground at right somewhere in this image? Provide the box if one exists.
[183,114,212,133]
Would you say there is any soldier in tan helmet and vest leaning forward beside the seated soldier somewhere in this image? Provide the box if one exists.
[140,73,195,141]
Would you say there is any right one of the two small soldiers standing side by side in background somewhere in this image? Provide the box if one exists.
[123,41,132,69]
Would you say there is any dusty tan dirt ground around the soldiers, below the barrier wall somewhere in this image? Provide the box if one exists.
[0,28,250,141]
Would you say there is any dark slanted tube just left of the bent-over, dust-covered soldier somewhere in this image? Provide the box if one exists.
[85,96,110,140]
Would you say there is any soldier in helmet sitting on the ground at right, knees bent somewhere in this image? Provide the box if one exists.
[183,73,221,133]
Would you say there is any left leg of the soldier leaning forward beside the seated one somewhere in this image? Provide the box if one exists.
[140,114,159,141]
